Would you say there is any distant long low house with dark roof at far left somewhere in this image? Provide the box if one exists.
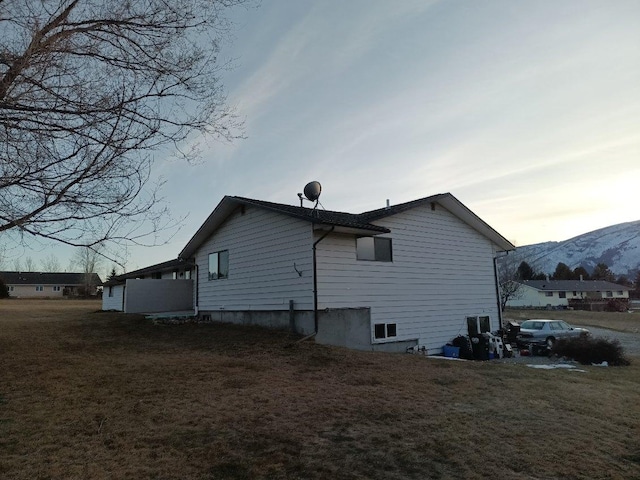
[0,272,102,298]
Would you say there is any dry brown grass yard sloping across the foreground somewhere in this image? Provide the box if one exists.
[0,300,640,480]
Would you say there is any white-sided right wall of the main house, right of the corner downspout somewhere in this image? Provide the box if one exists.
[316,205,499,353]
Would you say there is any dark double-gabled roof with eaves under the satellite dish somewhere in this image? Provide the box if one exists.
[178,193,515,258]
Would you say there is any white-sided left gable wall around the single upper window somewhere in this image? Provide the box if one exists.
[195,207,313,312]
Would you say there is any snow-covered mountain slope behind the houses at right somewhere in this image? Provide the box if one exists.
[509,220,640,279]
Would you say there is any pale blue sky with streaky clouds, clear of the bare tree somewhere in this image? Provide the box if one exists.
[6,0,640,270]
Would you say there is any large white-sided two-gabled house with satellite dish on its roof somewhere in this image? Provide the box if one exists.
[179,193,515,353]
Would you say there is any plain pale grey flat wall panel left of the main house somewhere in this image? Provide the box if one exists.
[124,279,193,313]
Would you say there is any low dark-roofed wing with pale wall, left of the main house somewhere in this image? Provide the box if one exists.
[102,260,194,313]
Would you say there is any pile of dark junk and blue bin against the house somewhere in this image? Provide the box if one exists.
[444,318,520,360]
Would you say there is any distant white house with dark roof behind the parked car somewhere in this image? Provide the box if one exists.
[507,280,631,307]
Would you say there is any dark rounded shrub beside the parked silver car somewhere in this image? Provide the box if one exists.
[551,335,630,366]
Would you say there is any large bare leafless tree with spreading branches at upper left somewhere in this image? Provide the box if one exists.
[0,0,246,262]
